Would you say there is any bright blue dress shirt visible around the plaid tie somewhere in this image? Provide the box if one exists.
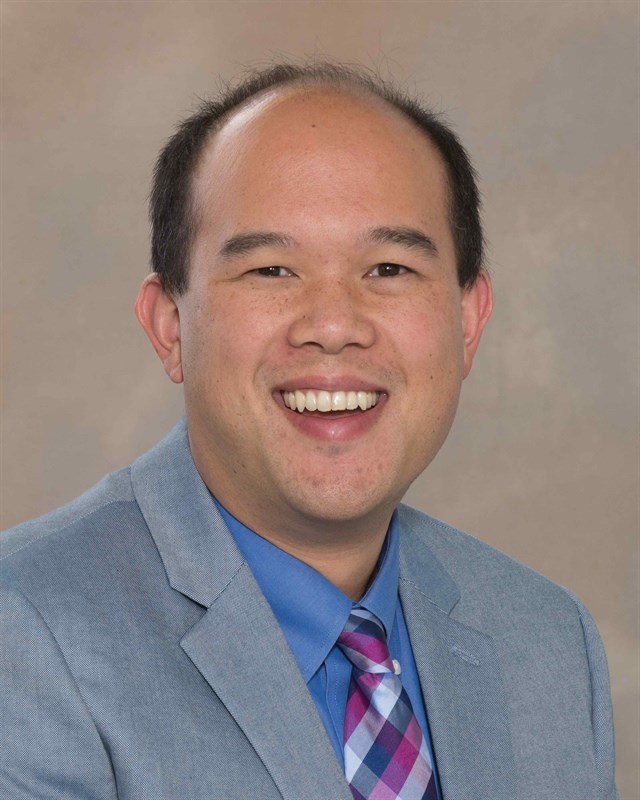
[214,498,441,798]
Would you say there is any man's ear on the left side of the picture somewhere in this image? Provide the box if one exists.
[135,272,183,383]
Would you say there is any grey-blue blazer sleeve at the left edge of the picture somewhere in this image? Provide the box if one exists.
[0,589,117,800]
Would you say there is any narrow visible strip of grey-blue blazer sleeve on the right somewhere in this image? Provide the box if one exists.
[570,593,618,800]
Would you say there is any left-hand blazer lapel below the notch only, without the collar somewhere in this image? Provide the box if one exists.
[181,565,352,800]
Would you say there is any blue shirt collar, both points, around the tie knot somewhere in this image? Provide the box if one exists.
[214,498,399,683]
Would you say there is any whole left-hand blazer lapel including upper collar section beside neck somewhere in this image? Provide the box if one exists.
[132,423,352,800]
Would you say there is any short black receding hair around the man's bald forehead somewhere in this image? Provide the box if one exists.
[149,61,484,296]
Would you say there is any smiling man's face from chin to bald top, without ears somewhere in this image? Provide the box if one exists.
[155,91,486,539]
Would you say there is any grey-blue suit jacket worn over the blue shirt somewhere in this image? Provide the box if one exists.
[0,423,616,800]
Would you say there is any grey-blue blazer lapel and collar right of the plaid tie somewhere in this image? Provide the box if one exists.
[400,506,516,800]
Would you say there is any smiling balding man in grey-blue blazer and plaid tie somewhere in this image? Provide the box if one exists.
[0,65,616,800]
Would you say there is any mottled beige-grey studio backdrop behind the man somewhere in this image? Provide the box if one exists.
[1,0,640,800]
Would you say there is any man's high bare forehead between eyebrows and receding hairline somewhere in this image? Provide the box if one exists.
[193,87,448,241]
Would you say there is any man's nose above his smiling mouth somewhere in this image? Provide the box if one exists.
[289,280,375,353]
